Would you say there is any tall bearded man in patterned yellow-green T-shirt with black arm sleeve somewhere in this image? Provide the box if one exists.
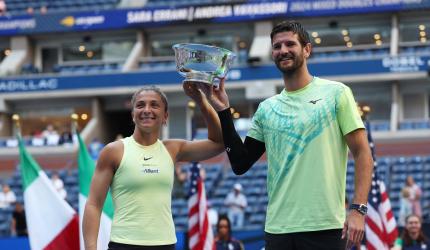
[208,21,373,250]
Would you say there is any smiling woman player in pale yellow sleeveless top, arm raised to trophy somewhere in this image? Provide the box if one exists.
[83,83,224,250]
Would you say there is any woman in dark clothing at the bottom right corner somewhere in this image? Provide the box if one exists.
[393,214,430,250]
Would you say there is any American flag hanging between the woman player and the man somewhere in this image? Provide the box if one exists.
[188,163,214,250]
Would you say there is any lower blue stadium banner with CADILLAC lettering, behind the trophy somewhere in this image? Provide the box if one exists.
[0,56,430,93]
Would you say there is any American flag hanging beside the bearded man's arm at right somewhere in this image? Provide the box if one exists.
[365,121,398,250]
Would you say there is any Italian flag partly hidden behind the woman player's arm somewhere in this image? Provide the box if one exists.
[77,133,114,250]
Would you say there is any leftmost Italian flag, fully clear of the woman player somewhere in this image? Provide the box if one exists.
[18,136,79,250]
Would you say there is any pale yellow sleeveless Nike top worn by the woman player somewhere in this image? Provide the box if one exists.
[110,136,176,246]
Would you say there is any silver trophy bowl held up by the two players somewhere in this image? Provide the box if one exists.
[172,43,236,86]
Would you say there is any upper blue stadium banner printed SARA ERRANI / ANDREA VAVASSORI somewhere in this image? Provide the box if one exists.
[0,0,430,36]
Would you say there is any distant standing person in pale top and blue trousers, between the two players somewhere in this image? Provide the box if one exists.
[224,183,248,229]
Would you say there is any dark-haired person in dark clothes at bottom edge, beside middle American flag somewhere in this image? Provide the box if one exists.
[215,215,244,250]
